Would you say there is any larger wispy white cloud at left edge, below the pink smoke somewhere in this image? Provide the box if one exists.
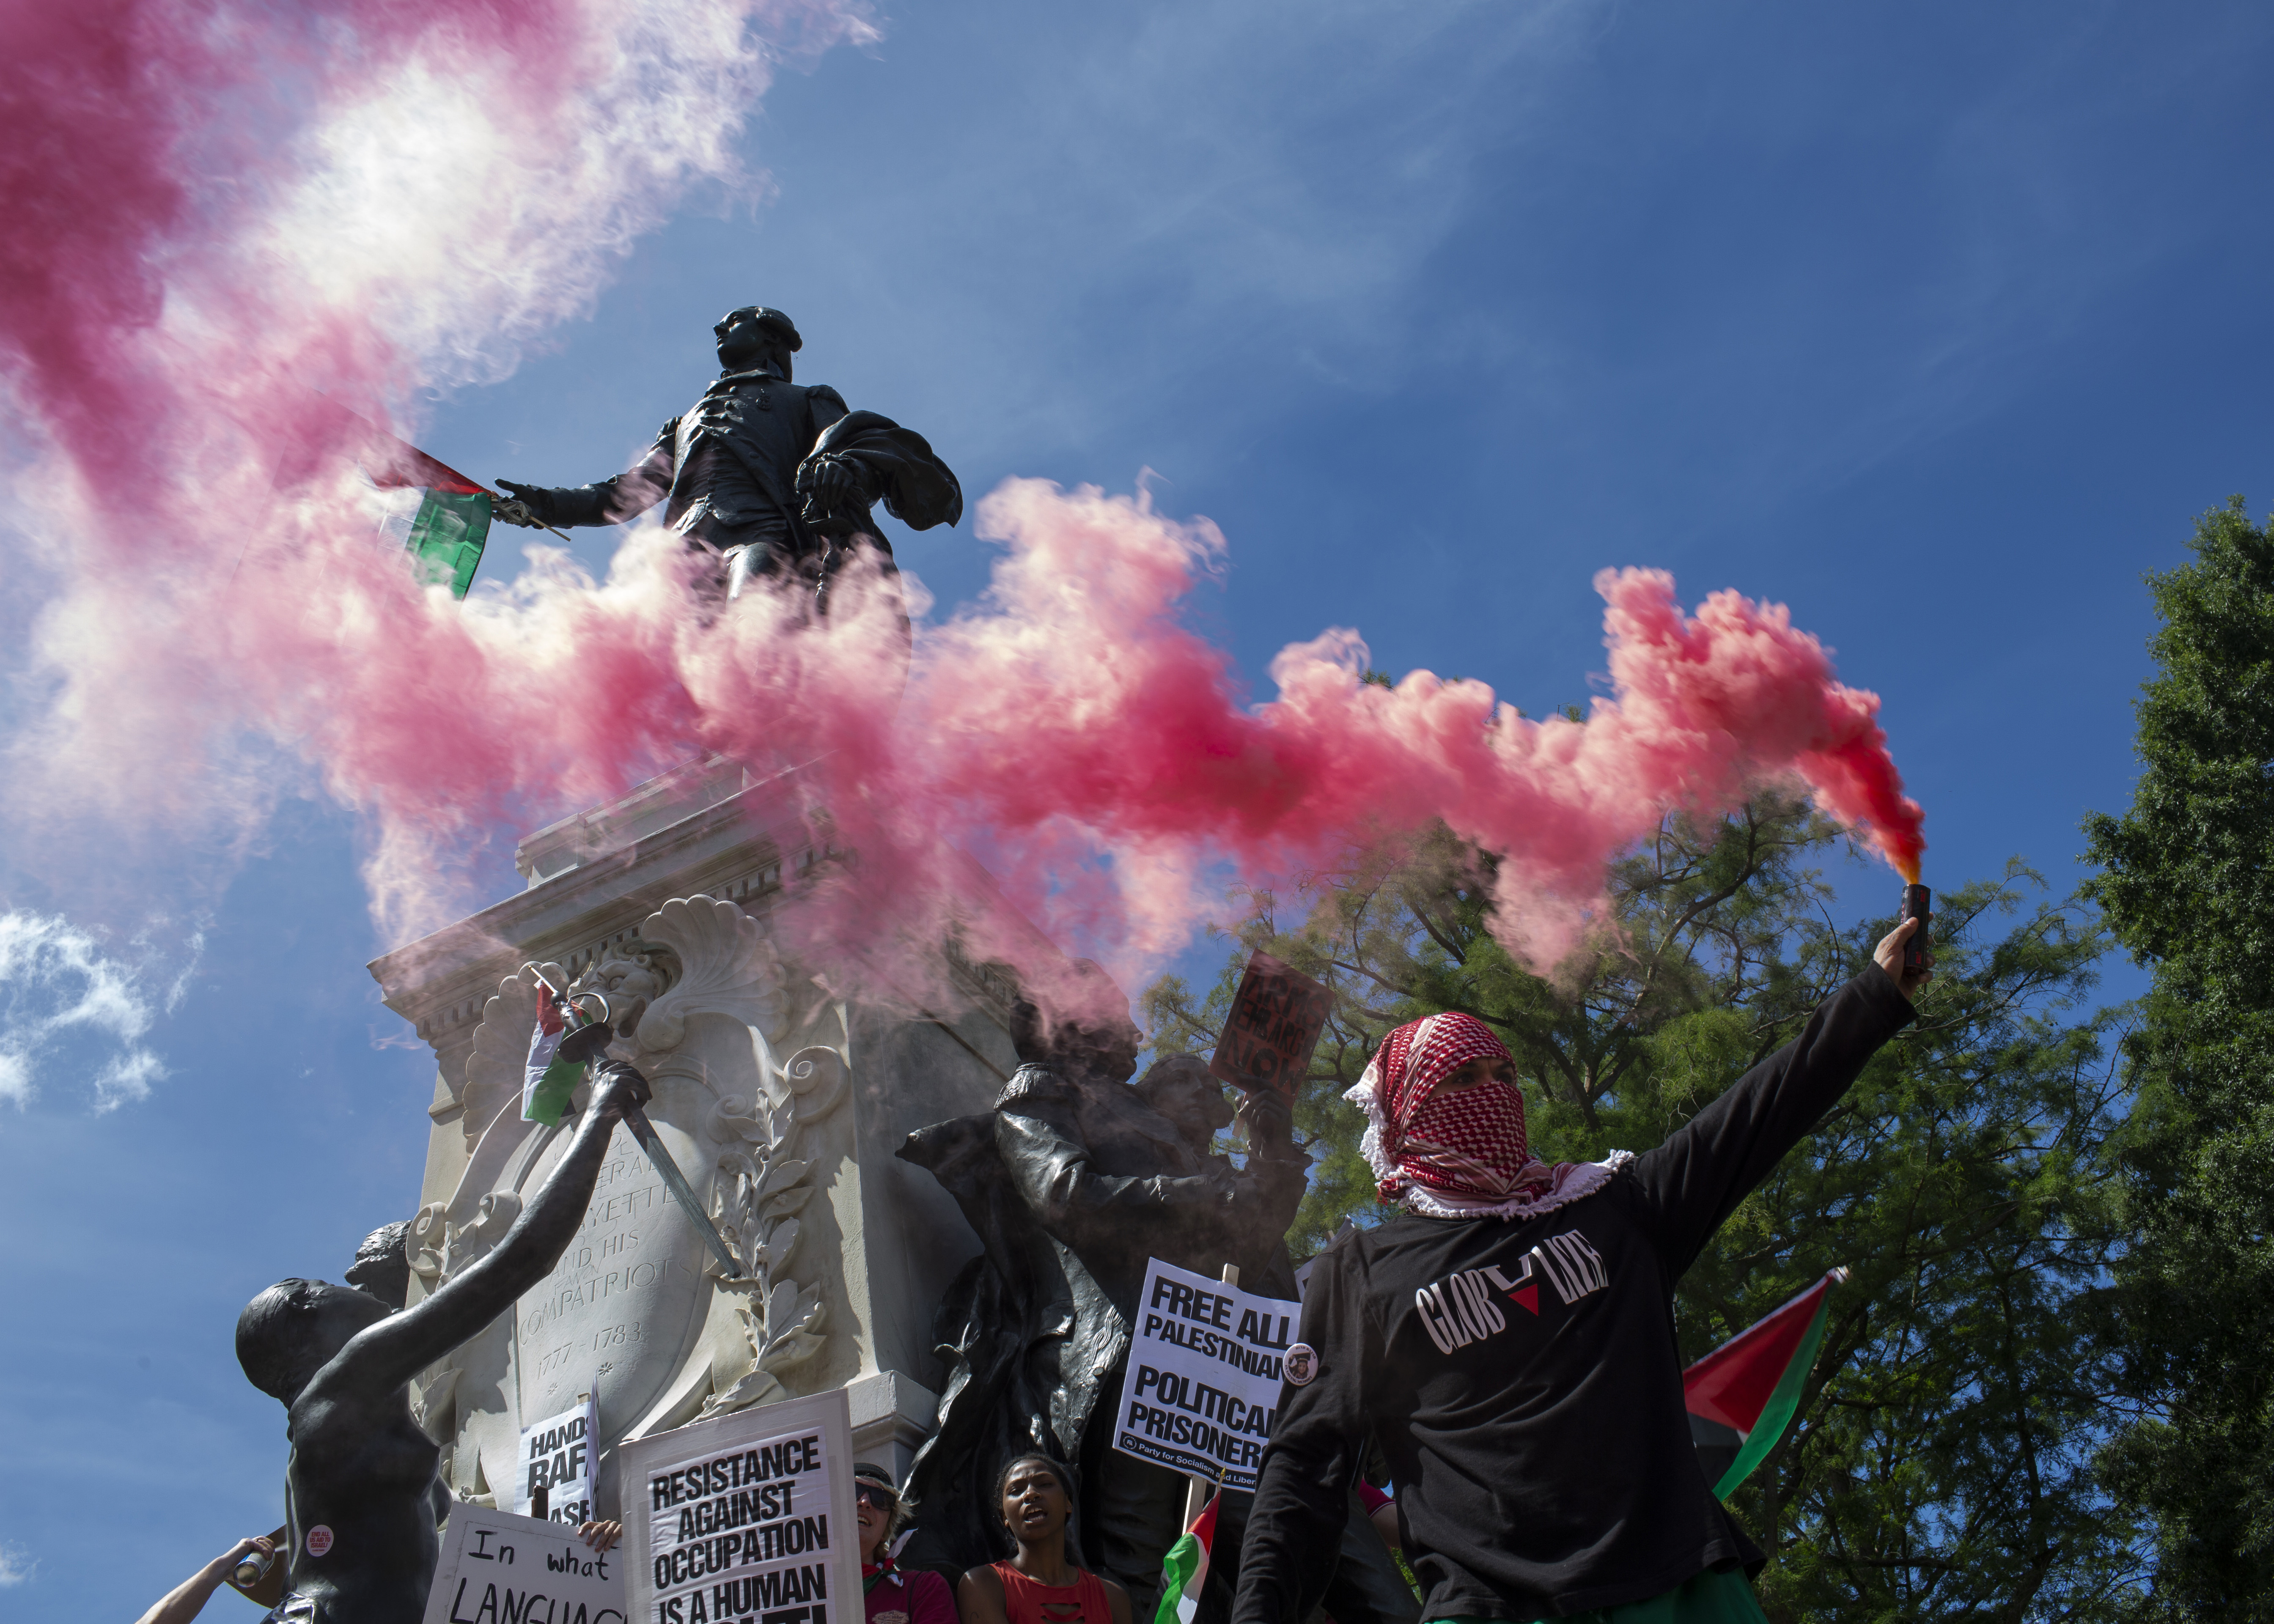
[0,910,189,1114]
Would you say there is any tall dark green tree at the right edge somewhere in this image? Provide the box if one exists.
[2085,496,2274,1619]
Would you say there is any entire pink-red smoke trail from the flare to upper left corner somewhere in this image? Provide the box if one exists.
[0,0,1922,1010]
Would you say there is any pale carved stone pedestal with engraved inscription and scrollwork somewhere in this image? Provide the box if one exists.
[371,762,1016,1515]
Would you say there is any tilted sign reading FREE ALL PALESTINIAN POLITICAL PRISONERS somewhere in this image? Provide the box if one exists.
[1114,1258,1303,1490]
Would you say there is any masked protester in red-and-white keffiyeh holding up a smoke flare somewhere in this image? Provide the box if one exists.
[1233,921,1928,1624]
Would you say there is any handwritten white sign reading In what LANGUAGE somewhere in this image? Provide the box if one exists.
[421,1506,625,1624]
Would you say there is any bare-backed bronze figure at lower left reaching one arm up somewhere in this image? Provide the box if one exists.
[236,1062,648,1624]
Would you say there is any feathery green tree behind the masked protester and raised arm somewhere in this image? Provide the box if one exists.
[1144,798,2142,1619]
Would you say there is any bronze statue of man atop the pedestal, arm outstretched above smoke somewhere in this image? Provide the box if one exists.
[498,305,964,628]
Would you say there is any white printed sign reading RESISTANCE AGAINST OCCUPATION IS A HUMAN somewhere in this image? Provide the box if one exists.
[616,1390,864,1624]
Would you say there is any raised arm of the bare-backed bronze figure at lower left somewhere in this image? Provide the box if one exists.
[325,1060,648,1390]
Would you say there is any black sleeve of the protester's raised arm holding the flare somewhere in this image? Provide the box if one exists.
[1628,964,1912,1278]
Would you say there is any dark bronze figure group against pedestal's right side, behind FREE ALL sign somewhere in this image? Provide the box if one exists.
[901,964,1412,1624]
